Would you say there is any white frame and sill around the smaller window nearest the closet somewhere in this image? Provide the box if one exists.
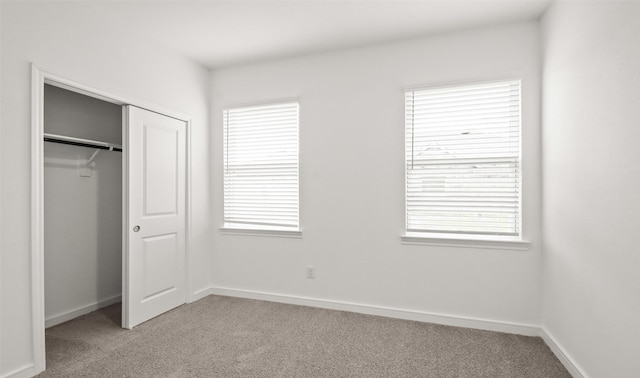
[219,98,302,238]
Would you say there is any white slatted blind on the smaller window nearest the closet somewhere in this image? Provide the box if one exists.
[224,102,299,230]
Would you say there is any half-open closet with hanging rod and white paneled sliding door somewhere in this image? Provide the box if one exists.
[40,82,189,332]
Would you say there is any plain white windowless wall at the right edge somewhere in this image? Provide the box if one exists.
[542,2,640,377]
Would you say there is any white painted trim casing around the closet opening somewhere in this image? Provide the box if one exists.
[29,63,191,376]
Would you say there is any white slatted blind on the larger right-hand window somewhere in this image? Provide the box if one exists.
[405,81,520,236]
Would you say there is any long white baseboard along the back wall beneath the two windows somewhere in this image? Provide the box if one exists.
[210,287,540,336]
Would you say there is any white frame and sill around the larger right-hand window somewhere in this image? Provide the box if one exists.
[400,77,531,251]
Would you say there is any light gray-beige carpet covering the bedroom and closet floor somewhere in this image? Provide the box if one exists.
[40,296,570,378]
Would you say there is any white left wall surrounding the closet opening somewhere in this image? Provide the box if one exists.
[0,1,211,375]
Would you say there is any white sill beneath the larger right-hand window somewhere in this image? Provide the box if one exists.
[400,233,531,251]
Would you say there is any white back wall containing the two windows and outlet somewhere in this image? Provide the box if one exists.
[211,22,541,326]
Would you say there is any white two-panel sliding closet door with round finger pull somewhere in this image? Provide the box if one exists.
[122,106,186,328]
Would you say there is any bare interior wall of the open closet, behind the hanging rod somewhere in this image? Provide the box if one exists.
[44,85,122,326]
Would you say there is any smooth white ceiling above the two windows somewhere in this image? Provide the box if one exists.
[94,0,551,68]
